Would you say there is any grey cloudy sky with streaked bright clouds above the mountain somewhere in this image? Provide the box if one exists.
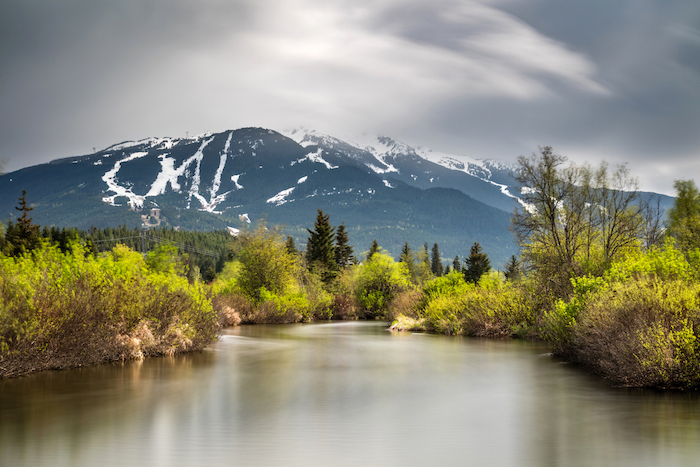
[0,0,700,194]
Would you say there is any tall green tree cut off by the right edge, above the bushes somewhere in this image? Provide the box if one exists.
[666,180,700,251]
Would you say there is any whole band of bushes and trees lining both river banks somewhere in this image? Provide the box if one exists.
[0,151,700,389]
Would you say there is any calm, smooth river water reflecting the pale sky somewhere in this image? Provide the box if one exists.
[0,322,700,467]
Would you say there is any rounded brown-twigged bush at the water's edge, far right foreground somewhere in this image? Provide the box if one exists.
[569,278,700,387]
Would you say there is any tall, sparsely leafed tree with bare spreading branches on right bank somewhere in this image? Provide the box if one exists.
[511,146,645,295]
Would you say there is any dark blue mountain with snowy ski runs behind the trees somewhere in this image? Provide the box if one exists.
[0,128,515,264]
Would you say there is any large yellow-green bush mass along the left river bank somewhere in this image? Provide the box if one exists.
[0,243,218,375]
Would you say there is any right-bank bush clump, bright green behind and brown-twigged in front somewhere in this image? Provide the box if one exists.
[543,241,700,387]
